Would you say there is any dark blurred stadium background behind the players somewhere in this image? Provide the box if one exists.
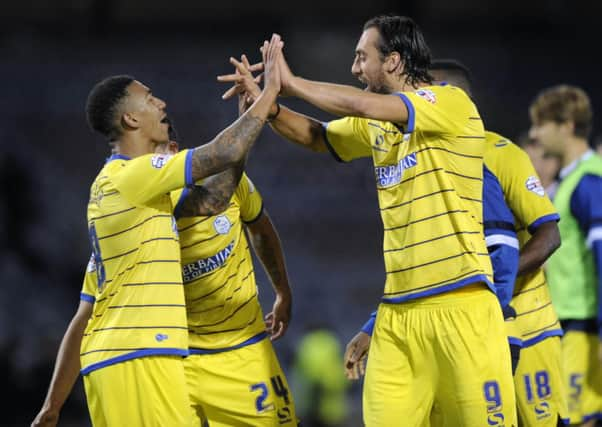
[0,0,602,426]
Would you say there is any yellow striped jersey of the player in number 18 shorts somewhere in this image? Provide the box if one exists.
[485,132,562,347]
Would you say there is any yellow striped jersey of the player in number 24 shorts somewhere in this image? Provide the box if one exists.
[172,174,266,354]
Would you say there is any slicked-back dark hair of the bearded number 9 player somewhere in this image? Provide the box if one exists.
[364,15,433,86]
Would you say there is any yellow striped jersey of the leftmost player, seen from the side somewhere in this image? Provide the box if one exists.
[81,150,193,374]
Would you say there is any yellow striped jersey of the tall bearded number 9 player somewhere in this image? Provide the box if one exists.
[325,85,493,302]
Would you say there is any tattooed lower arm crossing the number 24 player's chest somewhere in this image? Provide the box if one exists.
[180,161,245,217]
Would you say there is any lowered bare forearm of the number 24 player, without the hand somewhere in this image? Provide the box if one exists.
[247,210,290,294]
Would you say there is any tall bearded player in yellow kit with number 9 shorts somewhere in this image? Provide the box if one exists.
[219,16,516,427]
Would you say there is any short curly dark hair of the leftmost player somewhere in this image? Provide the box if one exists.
[86,75,135,140]
